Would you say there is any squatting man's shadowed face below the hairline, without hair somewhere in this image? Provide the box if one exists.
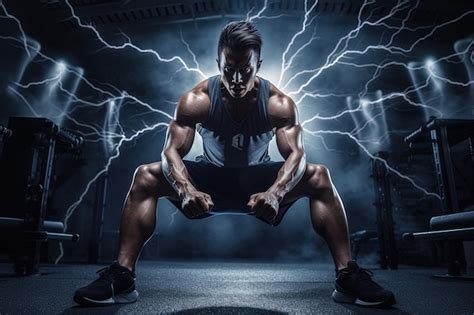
[217,47,261,98]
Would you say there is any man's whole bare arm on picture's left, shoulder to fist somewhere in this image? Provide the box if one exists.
[161,85,213,217]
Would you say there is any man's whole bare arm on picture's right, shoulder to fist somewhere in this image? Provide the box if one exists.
[248,95,306,222]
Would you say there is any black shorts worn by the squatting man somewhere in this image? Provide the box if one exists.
[169,160,295,226]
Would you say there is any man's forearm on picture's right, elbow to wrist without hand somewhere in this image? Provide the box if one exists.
[267,151,306,201]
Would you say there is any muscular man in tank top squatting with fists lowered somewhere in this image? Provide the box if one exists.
[74,22,395,306]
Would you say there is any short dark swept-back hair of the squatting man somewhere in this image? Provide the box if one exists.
[217,21,262,58]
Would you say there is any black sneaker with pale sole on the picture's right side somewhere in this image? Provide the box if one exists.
[332,260,396,307]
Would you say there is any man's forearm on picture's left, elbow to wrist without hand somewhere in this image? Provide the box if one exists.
[161,150,196,197]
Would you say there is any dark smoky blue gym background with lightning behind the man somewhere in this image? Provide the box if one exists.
[0,0,474,264]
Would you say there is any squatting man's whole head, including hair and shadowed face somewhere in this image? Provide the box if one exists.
[217,21,262,98]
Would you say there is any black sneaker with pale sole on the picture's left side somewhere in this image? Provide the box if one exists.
[74,262,138,305]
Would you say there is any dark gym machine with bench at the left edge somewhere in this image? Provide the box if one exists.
[0,117,82,275]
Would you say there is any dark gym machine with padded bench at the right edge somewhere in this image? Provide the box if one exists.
[403,117,474,280]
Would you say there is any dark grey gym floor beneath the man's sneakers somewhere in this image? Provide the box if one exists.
[0,261,474,315]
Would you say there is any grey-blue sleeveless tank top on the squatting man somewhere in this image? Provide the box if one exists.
[196,75,274,167]
